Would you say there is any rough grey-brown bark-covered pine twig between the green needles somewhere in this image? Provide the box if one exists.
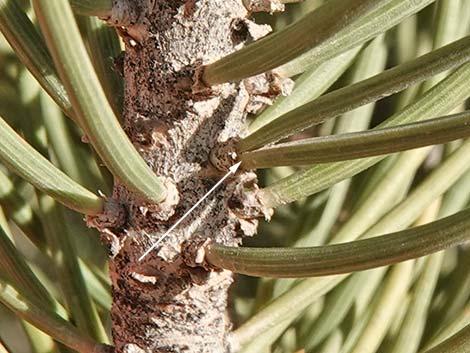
[93,0,278,353]
